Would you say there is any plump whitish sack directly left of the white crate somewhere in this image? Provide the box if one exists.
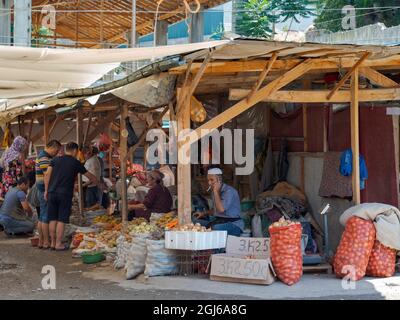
[144,239,179,277]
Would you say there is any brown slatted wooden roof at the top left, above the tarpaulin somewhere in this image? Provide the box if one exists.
[32,0,227,48]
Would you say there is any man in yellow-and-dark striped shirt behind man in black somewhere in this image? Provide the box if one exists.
[35,140,61,249]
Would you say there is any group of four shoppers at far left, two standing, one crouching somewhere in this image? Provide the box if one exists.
[0,136,100,251]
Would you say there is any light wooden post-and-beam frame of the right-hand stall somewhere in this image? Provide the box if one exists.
[169,42,400,222]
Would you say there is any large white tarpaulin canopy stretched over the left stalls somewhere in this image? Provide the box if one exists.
[0,41,229,121]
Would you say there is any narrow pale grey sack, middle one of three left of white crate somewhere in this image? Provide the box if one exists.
[125,238,147,280]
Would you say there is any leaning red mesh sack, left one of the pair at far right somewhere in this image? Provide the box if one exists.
[333,216,376,281]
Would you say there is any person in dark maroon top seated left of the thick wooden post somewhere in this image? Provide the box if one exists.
[128,170,172,220]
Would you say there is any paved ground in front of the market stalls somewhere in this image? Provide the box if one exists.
[0,234,400,300]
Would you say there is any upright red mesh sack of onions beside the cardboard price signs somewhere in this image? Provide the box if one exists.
[269,223,303,286]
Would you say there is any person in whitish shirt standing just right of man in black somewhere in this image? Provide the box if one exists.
[82,147,101,208]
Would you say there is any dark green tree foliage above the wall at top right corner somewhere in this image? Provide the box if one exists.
[314,0,400,32]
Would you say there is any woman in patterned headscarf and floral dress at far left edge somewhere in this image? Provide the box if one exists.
[0,136,28,198]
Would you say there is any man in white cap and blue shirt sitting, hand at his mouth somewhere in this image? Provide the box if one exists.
[194,168,244,237]
